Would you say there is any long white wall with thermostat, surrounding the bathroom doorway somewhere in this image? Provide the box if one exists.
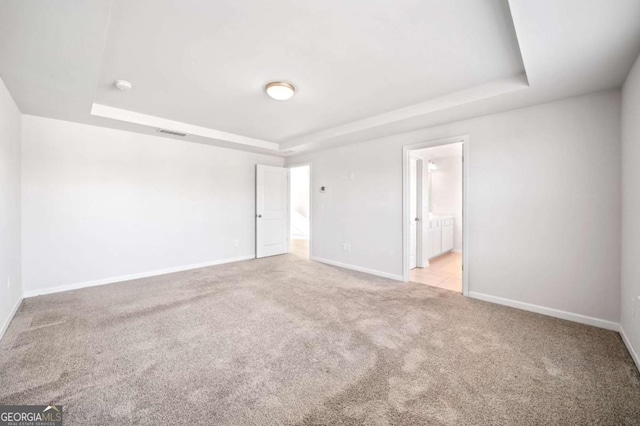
[289,90,621,323]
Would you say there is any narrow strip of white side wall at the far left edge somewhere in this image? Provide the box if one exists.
[0,75,22,337]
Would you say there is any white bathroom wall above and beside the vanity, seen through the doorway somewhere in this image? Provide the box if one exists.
[431,155,462,251]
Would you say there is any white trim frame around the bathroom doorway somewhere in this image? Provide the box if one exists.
[402,135,469,296]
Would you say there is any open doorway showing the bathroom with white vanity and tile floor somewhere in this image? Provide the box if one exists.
[404,137,468,294]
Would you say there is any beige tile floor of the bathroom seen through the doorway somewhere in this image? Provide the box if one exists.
[409,252,462,293]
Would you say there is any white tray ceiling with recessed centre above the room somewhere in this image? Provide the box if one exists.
[0,0,640,155]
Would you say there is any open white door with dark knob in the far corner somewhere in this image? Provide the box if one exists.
[256,164,289,258]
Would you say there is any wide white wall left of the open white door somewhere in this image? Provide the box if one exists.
[22,115,283,294]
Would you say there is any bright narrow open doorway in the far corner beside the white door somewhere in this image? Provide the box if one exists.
[289,164,311,259]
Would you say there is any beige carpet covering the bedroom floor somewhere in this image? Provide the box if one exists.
[0,254,640,426]
